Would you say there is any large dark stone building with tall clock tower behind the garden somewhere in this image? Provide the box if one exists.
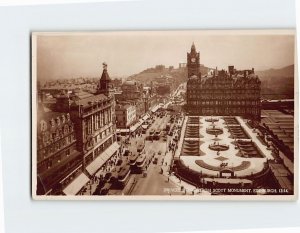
[186,44,261,120]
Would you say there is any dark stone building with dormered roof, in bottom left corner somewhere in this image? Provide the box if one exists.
[37,112,82,195]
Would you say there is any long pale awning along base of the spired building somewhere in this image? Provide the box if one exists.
[86,142,120,175]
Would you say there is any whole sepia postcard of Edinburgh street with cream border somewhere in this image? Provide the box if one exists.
[31,30,298,200]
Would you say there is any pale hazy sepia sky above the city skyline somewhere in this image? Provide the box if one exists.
[33,31,294,80]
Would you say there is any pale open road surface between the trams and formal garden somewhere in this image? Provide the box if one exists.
[119,111,183,195]
